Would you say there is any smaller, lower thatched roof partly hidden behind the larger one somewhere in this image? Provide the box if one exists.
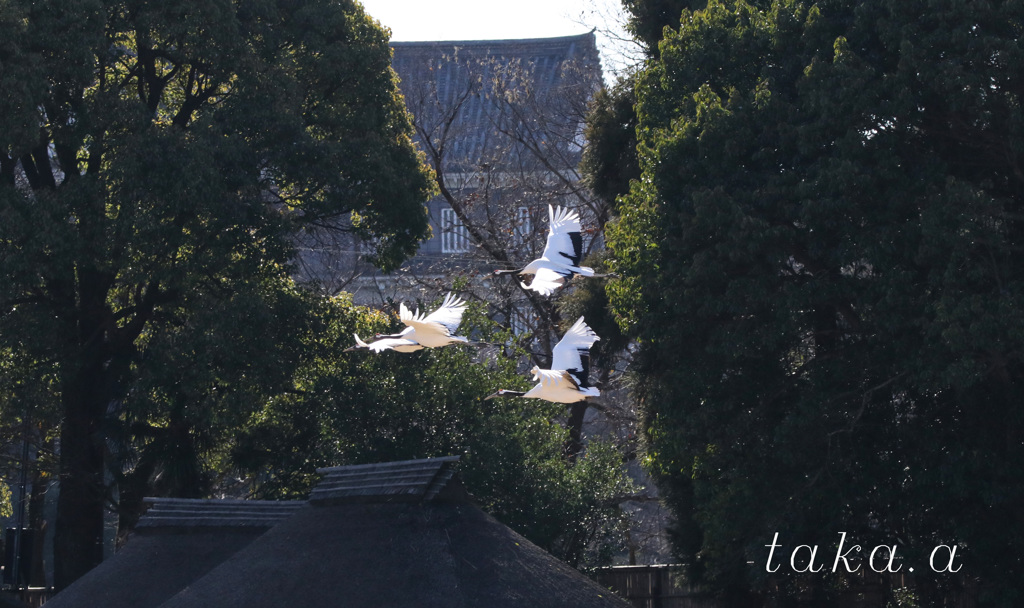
[46,498,304,608]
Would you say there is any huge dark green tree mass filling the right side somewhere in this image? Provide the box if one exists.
[608,0,1024,606]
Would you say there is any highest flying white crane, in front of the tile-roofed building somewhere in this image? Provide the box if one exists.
[495,205,605,296]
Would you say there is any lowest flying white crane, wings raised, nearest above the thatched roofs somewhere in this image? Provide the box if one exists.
[484,316,601,403]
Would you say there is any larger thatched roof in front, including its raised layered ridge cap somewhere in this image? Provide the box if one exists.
[161,459,628,608]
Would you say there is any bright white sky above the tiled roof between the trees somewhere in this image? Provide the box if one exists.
[360,0,623,77]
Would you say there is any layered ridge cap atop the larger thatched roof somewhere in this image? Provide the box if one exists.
[309,457,459,505]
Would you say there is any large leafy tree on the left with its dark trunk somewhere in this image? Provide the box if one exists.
[0,0,432,588]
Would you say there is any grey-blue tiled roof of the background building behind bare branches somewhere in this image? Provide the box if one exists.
[391,32,601,169]
